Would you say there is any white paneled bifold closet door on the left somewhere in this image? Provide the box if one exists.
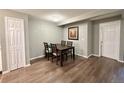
[5,17,25,70]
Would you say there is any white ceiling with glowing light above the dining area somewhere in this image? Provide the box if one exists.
[14,9,121,23]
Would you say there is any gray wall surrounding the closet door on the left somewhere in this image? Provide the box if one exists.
[0,10,30,71]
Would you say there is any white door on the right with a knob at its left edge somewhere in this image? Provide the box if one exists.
[100,20,120,59]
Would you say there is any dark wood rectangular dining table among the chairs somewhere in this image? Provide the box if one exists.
[56,44,75,66]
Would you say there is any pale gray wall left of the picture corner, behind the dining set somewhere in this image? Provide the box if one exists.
[29,16,63,58]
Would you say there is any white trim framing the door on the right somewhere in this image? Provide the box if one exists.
[99,20,121,60]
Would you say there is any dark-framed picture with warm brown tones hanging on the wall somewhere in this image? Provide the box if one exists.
[68,26,79,40]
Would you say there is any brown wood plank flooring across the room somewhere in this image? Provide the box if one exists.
[0,56,124,83]
